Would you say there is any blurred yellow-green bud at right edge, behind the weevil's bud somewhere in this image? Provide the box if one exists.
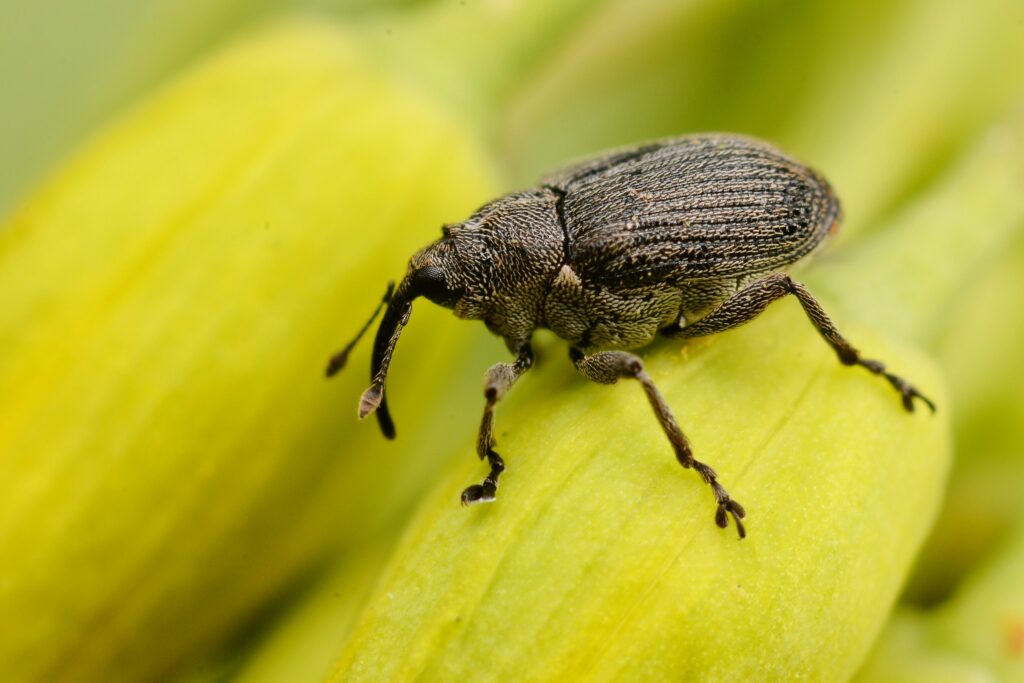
[908,231,1024,604]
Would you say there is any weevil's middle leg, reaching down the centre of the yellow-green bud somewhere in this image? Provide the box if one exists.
[569,348,746,539]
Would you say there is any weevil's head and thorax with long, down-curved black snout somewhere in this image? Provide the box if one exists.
[359,189,563,438]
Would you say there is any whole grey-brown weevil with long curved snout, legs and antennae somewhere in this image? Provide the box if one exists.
[327,134,935,538]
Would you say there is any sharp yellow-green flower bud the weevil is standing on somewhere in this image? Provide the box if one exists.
[332,301,949,681]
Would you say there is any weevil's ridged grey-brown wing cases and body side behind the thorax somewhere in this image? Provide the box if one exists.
[545,135,840,351]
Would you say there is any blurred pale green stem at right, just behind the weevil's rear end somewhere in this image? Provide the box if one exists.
[815,111,1024,348]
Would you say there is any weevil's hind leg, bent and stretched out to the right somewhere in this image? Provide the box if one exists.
[662,273,935,413]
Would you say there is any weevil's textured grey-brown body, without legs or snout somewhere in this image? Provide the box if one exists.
[423,135,840,352]
